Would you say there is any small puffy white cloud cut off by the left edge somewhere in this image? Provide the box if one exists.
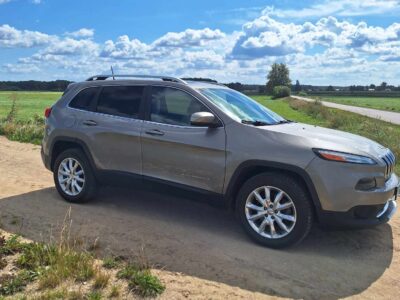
[0,24,54,48]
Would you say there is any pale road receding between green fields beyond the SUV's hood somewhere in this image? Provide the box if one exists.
[291,96,400,125]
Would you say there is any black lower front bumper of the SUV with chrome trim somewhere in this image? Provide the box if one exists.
[319,197,397,228]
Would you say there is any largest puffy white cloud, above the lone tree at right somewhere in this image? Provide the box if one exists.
[231,15,400,59]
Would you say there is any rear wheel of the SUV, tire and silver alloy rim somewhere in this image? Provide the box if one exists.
[53,148,96,203]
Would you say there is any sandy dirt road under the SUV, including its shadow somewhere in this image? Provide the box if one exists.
[0,137,400,299]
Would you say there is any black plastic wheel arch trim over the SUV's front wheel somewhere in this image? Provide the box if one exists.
[225,160,321,217]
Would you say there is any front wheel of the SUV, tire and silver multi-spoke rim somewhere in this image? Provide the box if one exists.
[236,172,313,248]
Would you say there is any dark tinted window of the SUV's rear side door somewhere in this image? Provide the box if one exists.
[97,86,144,118]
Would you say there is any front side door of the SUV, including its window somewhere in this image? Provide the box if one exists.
[141,86,225,193]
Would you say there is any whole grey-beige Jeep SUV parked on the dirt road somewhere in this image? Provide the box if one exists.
[42,75,399,248]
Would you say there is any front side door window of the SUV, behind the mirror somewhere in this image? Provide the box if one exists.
[150,87,209,126]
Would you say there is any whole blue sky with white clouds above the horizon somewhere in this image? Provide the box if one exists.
[0,0,400,85]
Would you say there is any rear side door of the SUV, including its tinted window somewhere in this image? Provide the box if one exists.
[72,85,145,175]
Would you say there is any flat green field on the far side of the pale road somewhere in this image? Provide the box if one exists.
[310,96,400,112]
